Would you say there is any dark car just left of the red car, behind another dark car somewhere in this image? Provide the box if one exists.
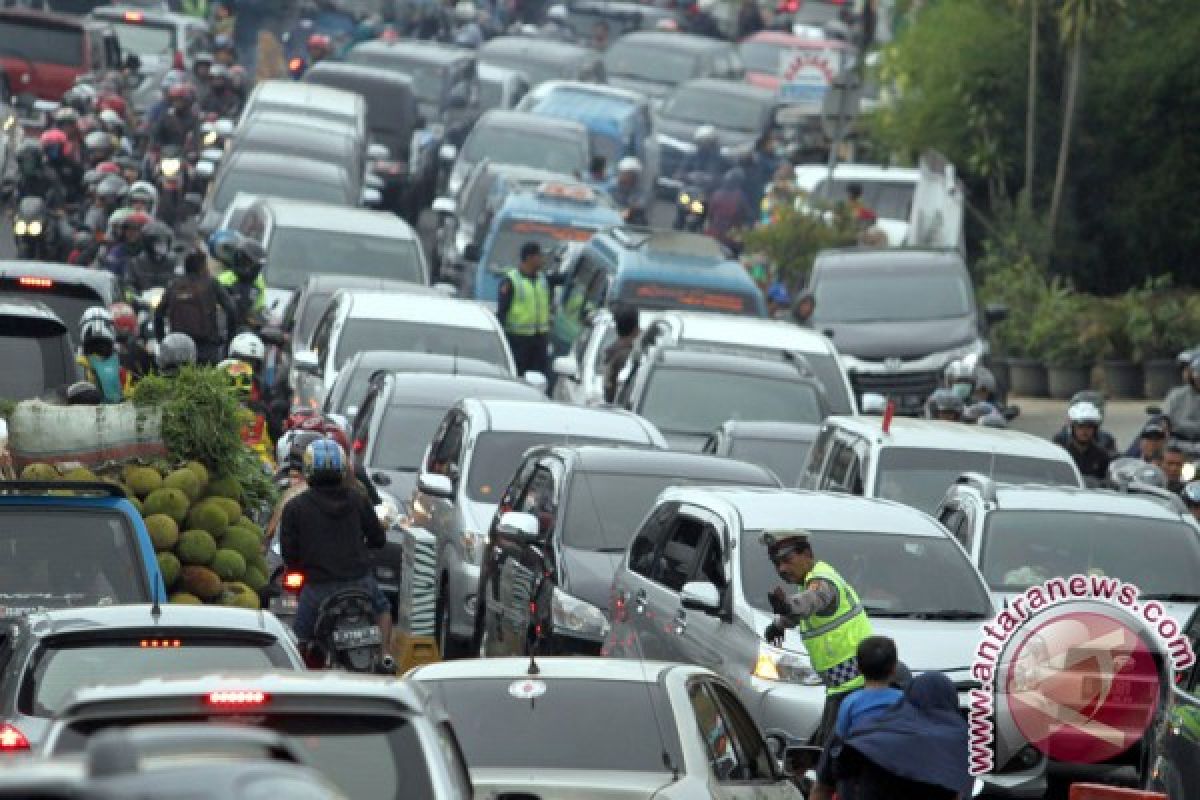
[604,31,745,102]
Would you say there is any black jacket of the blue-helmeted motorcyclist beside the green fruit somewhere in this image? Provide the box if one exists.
[280,486,388,583]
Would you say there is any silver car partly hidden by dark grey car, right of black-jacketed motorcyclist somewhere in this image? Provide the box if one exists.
[409,398,666,658]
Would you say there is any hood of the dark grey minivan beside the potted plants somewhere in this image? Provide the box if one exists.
[814,317,979,361]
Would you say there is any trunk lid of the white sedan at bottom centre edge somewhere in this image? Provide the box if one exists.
[470,766,672,800]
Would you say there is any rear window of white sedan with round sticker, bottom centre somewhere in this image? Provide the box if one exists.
[421,676,679,774]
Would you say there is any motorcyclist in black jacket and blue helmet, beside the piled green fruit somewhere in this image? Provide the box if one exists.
[280,439,391,662]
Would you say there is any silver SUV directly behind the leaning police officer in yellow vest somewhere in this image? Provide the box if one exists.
[604,487,1045,796]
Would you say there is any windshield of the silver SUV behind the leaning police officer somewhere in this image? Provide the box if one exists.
[737,530,992,619]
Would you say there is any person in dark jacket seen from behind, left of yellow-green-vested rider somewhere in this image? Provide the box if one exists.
[154,247,238,366]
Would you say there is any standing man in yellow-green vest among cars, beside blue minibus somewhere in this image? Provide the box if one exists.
[496,241,550,375]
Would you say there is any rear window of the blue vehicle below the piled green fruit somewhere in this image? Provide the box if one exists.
[0,510,150,618]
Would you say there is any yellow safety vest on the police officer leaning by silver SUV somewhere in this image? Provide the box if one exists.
[797,561,871,694]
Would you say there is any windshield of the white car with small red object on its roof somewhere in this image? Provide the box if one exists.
[875,447,1079,513]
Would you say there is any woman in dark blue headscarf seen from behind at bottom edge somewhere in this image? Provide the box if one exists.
[834,672,974,800]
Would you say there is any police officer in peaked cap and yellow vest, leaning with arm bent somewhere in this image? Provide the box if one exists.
[763,530,871,746]
